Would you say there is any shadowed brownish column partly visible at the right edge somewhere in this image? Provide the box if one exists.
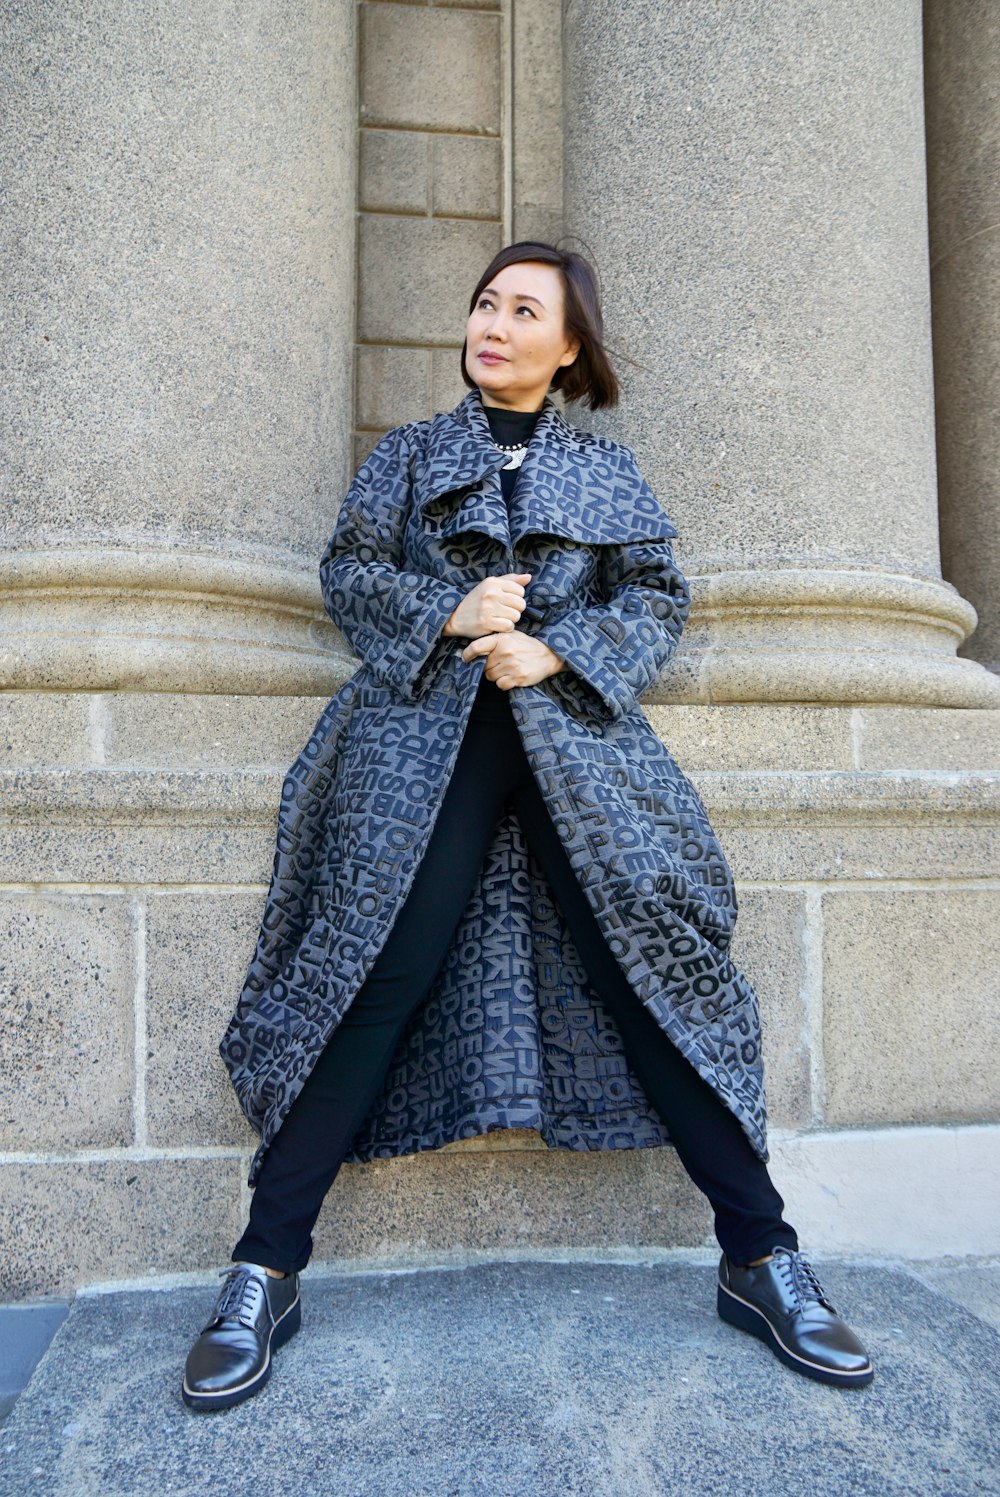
[924,0,1000,671]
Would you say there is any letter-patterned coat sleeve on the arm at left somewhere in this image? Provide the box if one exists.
[319,427,464,702]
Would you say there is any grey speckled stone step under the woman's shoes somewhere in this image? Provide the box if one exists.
[0,1257,1000,1497]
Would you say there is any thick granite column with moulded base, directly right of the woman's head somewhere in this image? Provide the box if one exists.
[564,0,1000,707]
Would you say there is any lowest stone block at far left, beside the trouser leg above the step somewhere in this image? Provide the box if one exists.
[0,1157,247,1299]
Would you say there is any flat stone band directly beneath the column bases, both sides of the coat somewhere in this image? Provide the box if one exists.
[0,697,1000,774]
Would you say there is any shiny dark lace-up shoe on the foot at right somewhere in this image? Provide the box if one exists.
[717,1247,874,1388]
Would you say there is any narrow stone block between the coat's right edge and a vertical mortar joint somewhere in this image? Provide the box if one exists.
[732,889,819,1127]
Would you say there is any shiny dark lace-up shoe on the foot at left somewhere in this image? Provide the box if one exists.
[181,1263,302,1410]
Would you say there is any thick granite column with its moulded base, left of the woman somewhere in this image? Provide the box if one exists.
[0,0,355,693]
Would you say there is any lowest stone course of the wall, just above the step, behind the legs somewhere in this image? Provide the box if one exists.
[0,1124,1000,1299]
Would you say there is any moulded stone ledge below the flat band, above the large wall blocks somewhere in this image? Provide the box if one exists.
[0,768,1000,886]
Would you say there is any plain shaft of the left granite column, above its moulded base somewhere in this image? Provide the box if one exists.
[0,0,354,562]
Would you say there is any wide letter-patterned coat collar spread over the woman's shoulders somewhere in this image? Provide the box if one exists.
[415,389,677,546]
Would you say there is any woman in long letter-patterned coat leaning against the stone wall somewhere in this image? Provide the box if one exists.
[183,243,873,1409]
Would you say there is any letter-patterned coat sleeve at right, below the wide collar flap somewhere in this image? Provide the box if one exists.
[536,540,690,722]
